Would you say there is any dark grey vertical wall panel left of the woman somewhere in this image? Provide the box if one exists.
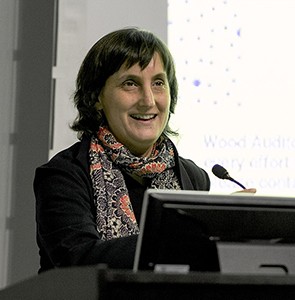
[8,0,55,284]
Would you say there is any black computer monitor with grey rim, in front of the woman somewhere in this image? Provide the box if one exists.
[134,189,295,273]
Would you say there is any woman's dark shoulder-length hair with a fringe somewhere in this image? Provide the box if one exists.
[71,27,178,137]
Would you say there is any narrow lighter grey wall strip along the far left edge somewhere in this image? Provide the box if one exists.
[0,0,16,288]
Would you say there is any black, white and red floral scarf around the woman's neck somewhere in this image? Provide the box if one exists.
[89,126,180,240]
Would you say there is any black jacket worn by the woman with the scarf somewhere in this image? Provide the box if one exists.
[34,138,210,272]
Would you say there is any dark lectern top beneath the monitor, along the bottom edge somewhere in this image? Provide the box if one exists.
[0,267,295,300]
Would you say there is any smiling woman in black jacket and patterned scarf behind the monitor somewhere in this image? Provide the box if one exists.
[34,28,210,272]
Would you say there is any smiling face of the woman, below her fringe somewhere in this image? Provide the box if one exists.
[97,53,170,156]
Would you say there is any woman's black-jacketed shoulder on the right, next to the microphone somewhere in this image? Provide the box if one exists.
[178,156,210,191]
